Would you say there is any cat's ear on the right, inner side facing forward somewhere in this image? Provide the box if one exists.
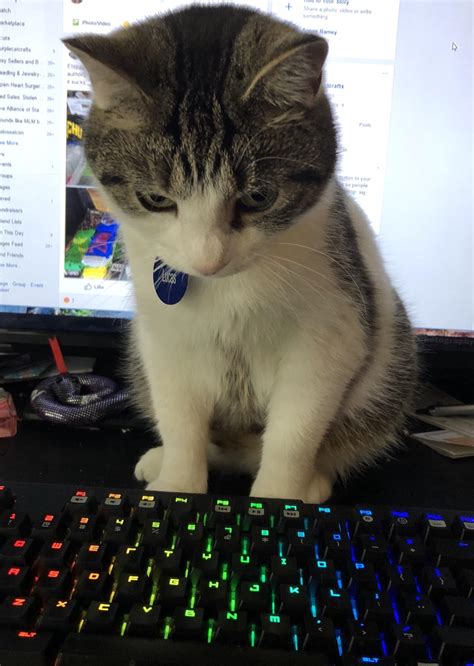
[242,35,328,110]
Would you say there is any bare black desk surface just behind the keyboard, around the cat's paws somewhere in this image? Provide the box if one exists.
[0,422,474,510]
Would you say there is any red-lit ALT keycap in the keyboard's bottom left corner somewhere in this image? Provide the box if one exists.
[0,629,54,666]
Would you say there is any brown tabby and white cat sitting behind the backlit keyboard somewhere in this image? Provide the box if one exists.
[65,5,416,503]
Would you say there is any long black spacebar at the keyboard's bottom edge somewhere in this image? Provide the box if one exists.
[56,634,329,666]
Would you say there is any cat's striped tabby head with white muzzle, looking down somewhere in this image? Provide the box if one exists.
[65,6,336,276]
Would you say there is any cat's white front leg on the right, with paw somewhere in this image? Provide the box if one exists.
[251,340,360,501]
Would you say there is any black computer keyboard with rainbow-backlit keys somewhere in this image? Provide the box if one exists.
[0,483,474,666]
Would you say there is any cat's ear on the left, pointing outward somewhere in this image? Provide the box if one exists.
[63,35,146,115]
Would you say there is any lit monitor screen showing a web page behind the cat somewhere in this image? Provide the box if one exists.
[0,0,474,336]
